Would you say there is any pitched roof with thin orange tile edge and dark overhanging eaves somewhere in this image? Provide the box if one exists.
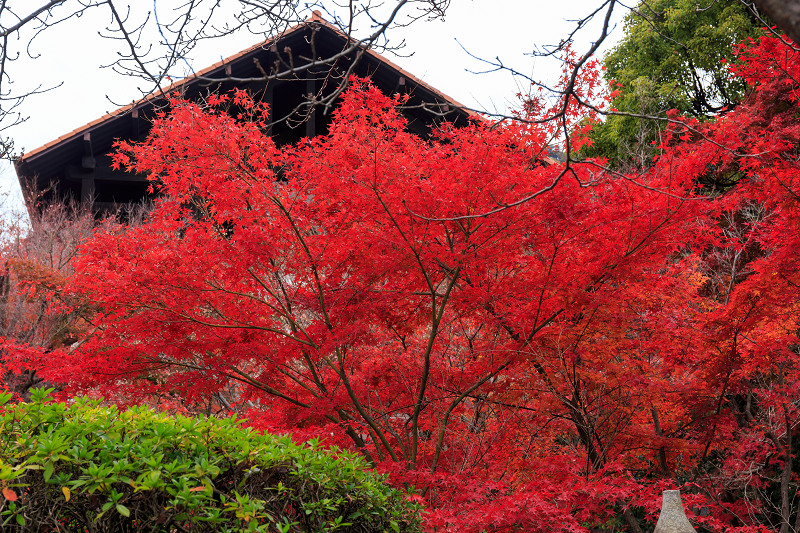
[15,12,477,207]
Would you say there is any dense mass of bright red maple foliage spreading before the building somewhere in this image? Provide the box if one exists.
[7,38,800,532]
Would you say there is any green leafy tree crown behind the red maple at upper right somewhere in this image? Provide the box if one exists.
[582,0,764,168]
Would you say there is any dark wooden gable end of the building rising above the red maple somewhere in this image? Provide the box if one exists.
[15,14,470,213]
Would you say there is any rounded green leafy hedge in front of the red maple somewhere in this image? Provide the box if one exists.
[0,390,420,532]
